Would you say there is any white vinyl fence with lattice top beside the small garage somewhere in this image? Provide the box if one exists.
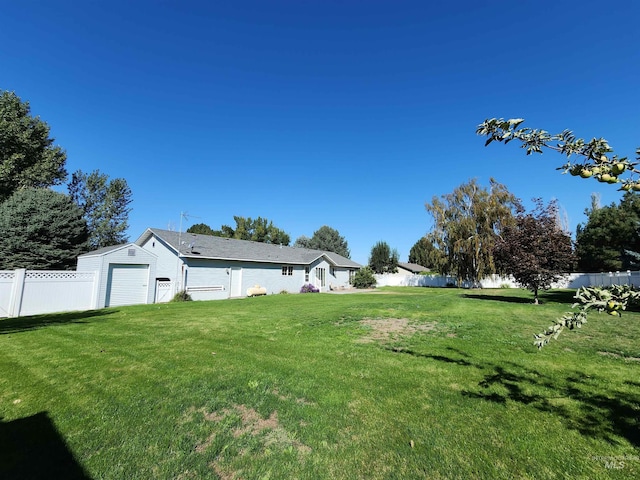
[0,269,98,317]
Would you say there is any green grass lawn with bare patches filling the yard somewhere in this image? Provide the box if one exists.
[0,287,640,479]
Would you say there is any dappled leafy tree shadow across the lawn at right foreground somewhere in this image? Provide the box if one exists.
[395,348,640,447]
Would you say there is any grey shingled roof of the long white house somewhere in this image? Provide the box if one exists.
[135,228,362,268]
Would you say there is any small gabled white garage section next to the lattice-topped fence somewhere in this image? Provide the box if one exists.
[77,243,157,307]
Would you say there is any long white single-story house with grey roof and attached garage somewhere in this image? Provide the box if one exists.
[77,228,361,306]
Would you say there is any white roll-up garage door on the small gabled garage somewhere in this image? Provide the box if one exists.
[106,264,149,307]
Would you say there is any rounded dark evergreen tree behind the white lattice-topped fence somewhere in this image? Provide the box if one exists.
[0,188,88,270]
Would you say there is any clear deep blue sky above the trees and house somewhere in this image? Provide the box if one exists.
[0,0,640,263]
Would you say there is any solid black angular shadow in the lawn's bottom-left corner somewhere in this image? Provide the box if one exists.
[0,412,91,480]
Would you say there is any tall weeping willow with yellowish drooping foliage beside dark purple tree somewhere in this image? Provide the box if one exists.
[425,178,518,285]
